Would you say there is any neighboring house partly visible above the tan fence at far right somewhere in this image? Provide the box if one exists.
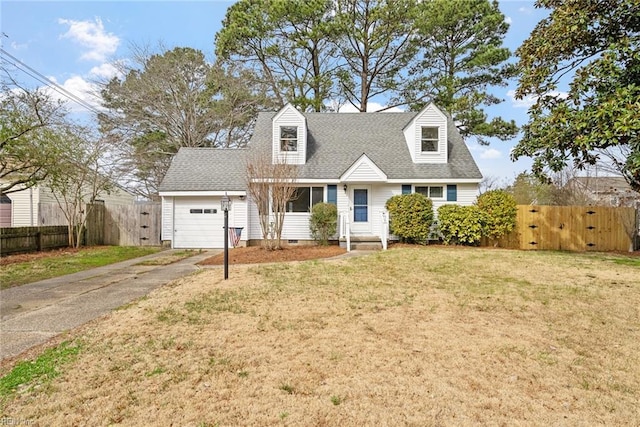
[567,176,640,207]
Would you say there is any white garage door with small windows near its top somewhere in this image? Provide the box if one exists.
[173,197,224,249]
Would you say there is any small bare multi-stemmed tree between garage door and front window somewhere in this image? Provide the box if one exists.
[246,152,298,250]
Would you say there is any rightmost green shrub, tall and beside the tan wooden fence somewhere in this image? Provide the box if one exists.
[476,190,518,239]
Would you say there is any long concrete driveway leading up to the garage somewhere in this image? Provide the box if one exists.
[0,251,219,360]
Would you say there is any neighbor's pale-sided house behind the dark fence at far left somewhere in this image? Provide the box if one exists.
[2,184,136,227]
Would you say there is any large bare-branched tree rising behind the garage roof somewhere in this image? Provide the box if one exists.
[98,46,267,198]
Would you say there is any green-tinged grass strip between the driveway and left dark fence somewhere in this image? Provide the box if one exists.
[0,246,160,289]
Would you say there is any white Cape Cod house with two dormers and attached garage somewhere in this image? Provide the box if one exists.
[160,104,482,248]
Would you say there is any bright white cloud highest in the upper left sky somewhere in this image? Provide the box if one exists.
[58,18,120,61]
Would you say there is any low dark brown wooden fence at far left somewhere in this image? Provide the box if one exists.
[0,225,69,256]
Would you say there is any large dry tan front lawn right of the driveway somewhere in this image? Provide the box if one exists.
[2,247,640,426]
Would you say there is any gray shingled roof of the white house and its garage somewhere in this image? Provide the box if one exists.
[160,113,482,191]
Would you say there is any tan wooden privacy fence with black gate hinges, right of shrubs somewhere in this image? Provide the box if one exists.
[499,205,638,251]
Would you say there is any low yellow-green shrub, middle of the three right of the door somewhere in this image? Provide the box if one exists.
[438,205,486,245]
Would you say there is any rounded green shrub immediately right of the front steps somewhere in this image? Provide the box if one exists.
[386,193,433,243]
